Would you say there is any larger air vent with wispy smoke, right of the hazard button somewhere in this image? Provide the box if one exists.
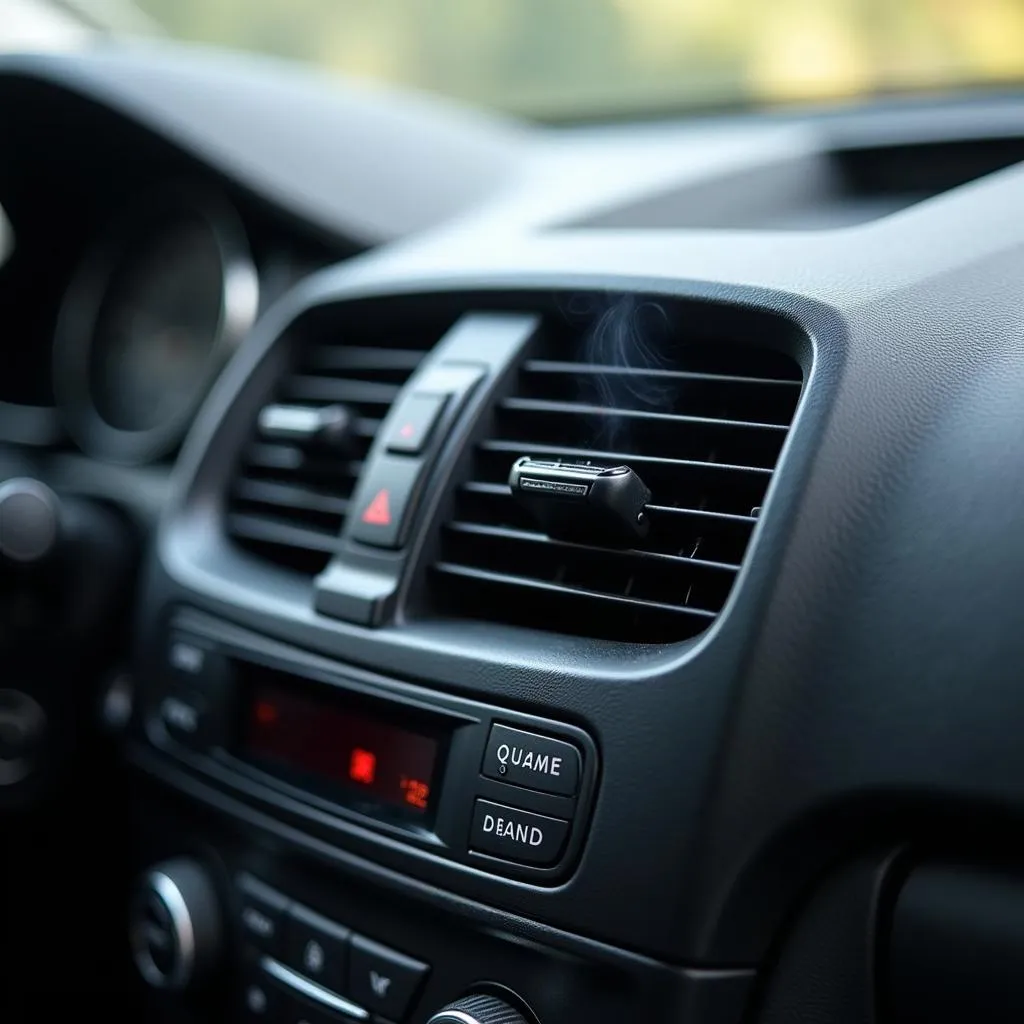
[432,300,803,643]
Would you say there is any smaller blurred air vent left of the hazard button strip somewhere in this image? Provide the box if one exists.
[226,325,444,575]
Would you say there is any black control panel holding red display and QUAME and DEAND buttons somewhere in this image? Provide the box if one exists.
[144,610,598,885]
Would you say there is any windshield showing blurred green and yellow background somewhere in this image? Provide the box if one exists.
[19,0,1024,118]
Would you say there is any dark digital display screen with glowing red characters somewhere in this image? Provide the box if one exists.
[242,681,440,821]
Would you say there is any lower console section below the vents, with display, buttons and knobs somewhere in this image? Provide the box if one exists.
[131,609,724,1024]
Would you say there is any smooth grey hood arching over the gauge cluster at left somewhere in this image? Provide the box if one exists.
[0,41,532,246]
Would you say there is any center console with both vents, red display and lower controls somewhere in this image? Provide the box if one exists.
[125,249,809,1024]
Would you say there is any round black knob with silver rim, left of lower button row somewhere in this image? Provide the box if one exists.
[130,857,223,991]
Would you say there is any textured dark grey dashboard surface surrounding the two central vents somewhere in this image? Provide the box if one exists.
[9,44,1024,965]
